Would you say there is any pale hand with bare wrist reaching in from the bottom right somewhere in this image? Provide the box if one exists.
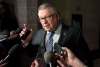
[57,47,87,67]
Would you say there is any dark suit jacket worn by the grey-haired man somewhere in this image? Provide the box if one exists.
[32,24,89,64]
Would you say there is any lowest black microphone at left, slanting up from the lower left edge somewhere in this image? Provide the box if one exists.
[0,44,20,64]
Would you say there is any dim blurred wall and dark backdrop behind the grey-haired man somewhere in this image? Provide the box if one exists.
[0,0,100,67]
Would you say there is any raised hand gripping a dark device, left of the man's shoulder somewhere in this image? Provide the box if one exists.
[19,24,33,47]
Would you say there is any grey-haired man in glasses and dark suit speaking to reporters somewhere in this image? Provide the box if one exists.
[29,3,89,67]
